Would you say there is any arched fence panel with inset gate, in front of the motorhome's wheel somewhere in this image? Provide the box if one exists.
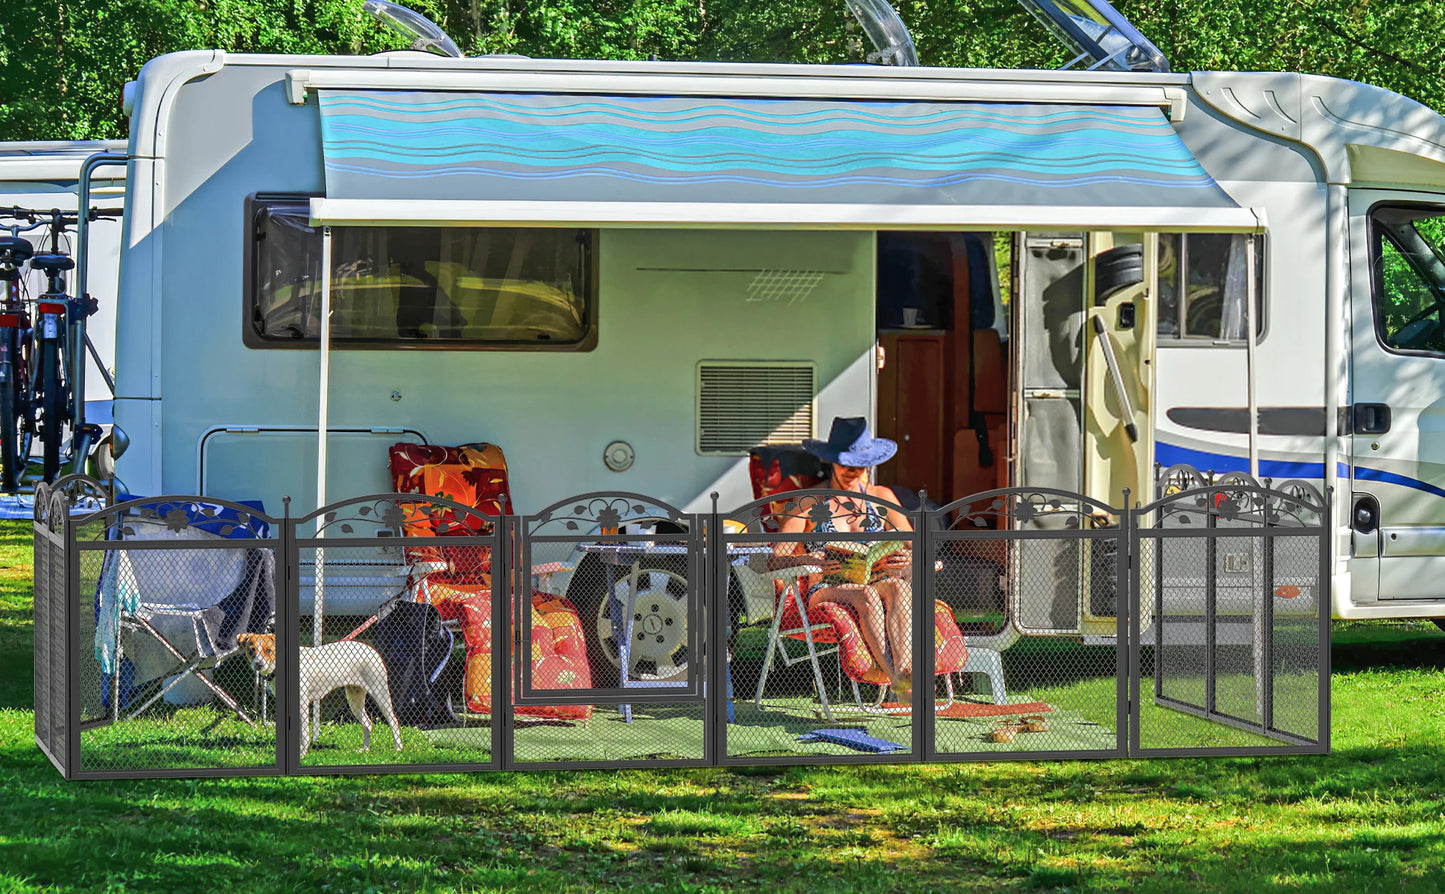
[507,491,711,767]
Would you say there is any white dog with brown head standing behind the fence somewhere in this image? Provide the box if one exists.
[236,633,402,757]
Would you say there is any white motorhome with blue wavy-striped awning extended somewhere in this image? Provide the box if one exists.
[93,5,1445,658]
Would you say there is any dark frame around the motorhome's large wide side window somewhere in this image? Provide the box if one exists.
[240,192,601,354]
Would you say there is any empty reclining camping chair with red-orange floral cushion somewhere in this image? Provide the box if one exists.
[389,443,592,722]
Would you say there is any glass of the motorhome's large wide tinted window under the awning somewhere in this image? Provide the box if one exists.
[250,204,595,348]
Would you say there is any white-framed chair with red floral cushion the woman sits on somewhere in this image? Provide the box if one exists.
[749,448,1004,721]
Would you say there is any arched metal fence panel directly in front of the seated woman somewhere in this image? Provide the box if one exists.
[715,490,924,764]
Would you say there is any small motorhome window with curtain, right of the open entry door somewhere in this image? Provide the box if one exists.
[1159,233,1264,342]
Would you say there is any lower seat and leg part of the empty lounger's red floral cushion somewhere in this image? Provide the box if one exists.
[425,575,592,721]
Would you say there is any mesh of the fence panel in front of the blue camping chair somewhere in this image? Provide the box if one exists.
[72,537,276,771]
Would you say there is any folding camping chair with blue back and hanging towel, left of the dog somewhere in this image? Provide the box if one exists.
[95,503,276,726]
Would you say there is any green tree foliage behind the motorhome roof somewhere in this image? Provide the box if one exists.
[0,0,1445,140]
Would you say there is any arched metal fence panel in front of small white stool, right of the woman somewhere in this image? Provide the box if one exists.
[929,488,1129,760]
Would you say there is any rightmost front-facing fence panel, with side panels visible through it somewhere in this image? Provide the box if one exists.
[1130,468,1329,755]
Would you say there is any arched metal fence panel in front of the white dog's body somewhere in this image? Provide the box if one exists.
[286,494,507,774]
